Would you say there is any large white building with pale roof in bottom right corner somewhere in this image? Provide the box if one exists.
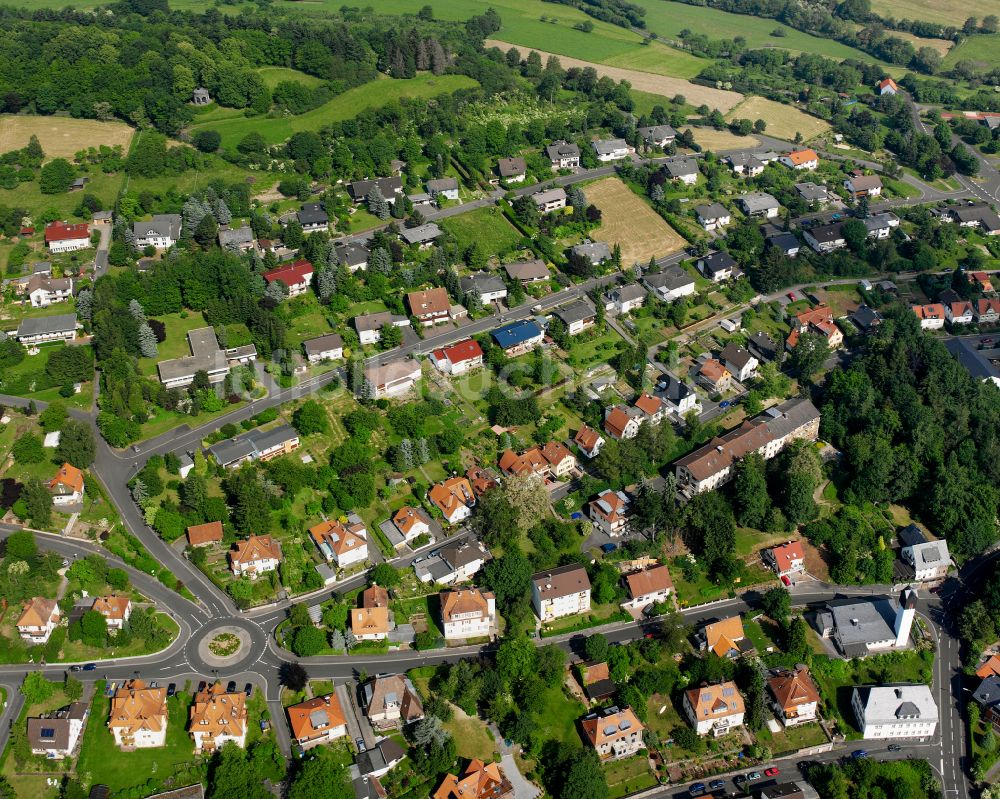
[851,683,938,740]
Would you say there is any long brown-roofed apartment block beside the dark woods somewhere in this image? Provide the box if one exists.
[675,397,819,497]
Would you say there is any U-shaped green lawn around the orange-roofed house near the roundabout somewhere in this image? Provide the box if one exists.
[76,682,194,793]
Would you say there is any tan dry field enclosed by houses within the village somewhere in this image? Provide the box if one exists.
[584,178,686,267]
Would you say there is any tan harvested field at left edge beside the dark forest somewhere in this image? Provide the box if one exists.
[0,114,135,160]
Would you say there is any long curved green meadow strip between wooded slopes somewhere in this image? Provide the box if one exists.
[191,74,477,148]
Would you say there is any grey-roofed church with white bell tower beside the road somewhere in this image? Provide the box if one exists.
[814,588,917,658]
